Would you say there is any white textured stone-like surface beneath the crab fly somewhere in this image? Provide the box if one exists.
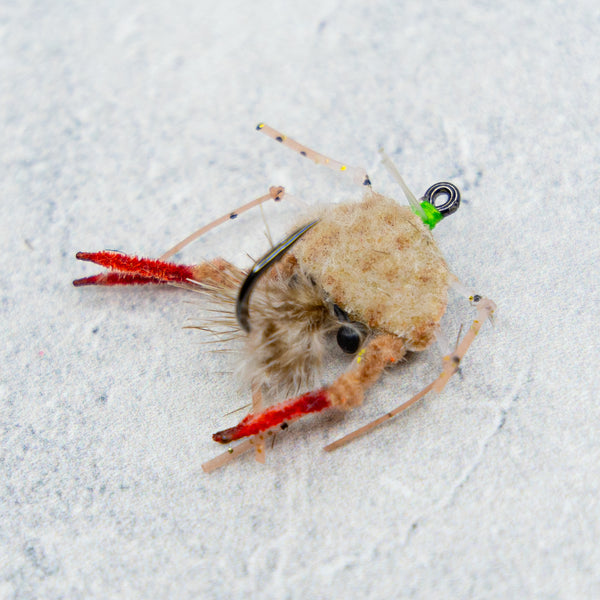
[0,0,600,599]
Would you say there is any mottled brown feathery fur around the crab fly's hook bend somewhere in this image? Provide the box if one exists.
[188,255,346,398]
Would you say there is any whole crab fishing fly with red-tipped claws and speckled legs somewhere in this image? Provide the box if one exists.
[73,123,496,471]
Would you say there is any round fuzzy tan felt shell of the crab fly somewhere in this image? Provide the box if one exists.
[291,192,450,350]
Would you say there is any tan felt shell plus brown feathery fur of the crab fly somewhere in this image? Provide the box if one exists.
[195,192,449,398]
